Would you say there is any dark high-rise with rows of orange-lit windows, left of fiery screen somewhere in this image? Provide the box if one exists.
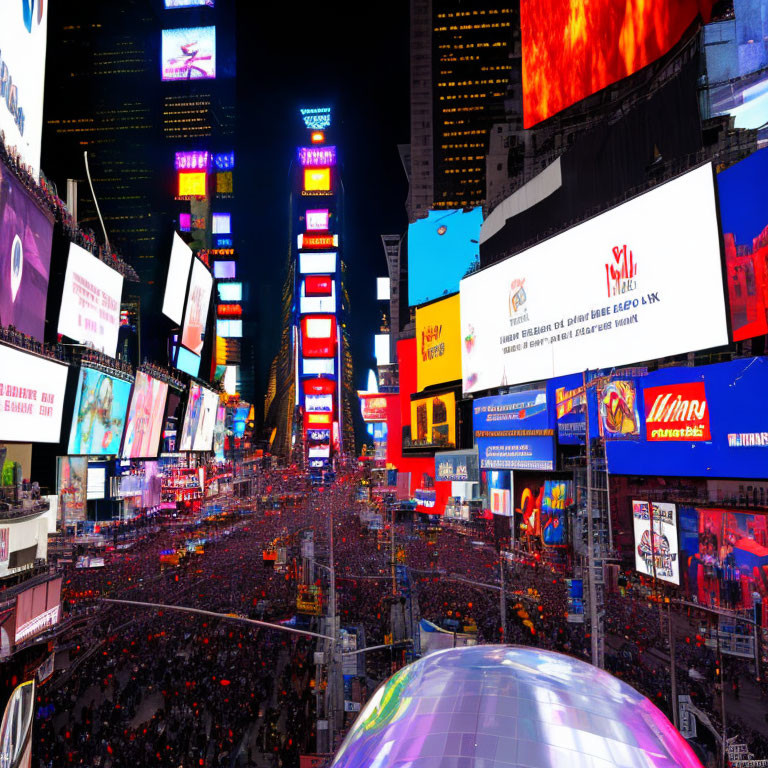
[409,0,519,221]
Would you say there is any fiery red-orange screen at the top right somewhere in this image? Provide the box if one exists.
[520,0,714,128]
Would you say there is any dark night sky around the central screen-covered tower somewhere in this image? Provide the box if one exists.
[234,0,409,420]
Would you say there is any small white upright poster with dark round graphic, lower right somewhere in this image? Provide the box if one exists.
[632,501,680,586]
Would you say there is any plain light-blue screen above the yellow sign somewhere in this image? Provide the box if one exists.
[408,206,483,306]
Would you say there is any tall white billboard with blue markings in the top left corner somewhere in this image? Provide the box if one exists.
[0,0,48,178]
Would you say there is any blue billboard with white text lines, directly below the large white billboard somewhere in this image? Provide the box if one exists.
[473,389,555,470]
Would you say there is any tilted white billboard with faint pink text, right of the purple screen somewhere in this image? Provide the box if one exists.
[58,243,123,357]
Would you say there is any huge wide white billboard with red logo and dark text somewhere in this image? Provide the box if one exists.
[461,165,728,392]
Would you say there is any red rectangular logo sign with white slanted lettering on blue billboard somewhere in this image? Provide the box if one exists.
[644,381,712,441]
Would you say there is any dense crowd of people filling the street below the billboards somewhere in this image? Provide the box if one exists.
[27,471,768,768]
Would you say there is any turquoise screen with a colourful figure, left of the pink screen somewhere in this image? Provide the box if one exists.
[67,368,131,456]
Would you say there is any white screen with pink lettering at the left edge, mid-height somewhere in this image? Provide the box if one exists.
[0,344,68,443]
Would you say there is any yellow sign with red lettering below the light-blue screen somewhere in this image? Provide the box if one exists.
[416,294,461,391]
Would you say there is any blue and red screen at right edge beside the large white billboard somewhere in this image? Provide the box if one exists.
[717,149,768,341]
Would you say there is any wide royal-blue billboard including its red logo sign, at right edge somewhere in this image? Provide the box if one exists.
[606,357,768,478]
